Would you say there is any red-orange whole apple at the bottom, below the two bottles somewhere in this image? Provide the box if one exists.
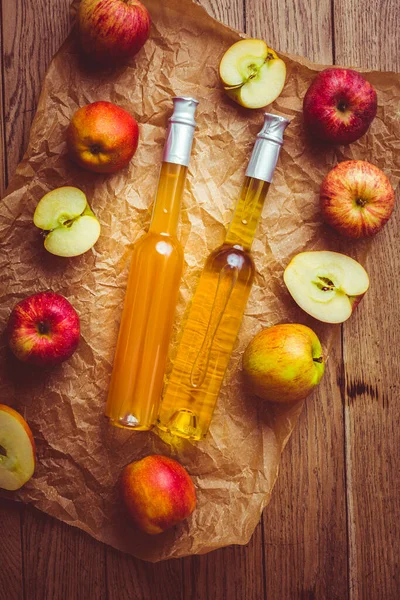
[120,454,196,535]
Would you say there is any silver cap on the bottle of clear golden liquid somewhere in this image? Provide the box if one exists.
[246,113,290,182]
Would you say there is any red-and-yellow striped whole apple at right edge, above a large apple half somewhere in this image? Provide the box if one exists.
[320,160,395,238]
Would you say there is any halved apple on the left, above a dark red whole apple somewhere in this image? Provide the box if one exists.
[33,186,100,257]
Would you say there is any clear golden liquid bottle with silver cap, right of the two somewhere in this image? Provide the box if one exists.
[157,113,289,440]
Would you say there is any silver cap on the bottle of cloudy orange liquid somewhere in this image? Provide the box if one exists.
[162,96,198,167]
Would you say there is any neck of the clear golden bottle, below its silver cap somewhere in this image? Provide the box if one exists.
[225,177,270,251]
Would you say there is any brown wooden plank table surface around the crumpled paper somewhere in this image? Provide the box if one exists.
[0,0,400,600]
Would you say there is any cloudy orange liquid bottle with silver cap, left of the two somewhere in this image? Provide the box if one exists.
[106,97,198,431]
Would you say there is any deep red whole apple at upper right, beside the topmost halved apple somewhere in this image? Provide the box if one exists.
[303,68,377,144]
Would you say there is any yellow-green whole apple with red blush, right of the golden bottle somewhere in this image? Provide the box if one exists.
[243,323,325,403]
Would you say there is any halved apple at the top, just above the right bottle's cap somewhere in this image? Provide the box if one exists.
[219,39,286,108]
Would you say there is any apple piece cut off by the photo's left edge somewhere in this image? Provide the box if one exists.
[0,404,36,491]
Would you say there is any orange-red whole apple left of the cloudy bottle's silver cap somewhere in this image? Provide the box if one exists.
[67,101,139,173]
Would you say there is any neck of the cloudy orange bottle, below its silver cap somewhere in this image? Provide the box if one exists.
[149,162,187,237]
